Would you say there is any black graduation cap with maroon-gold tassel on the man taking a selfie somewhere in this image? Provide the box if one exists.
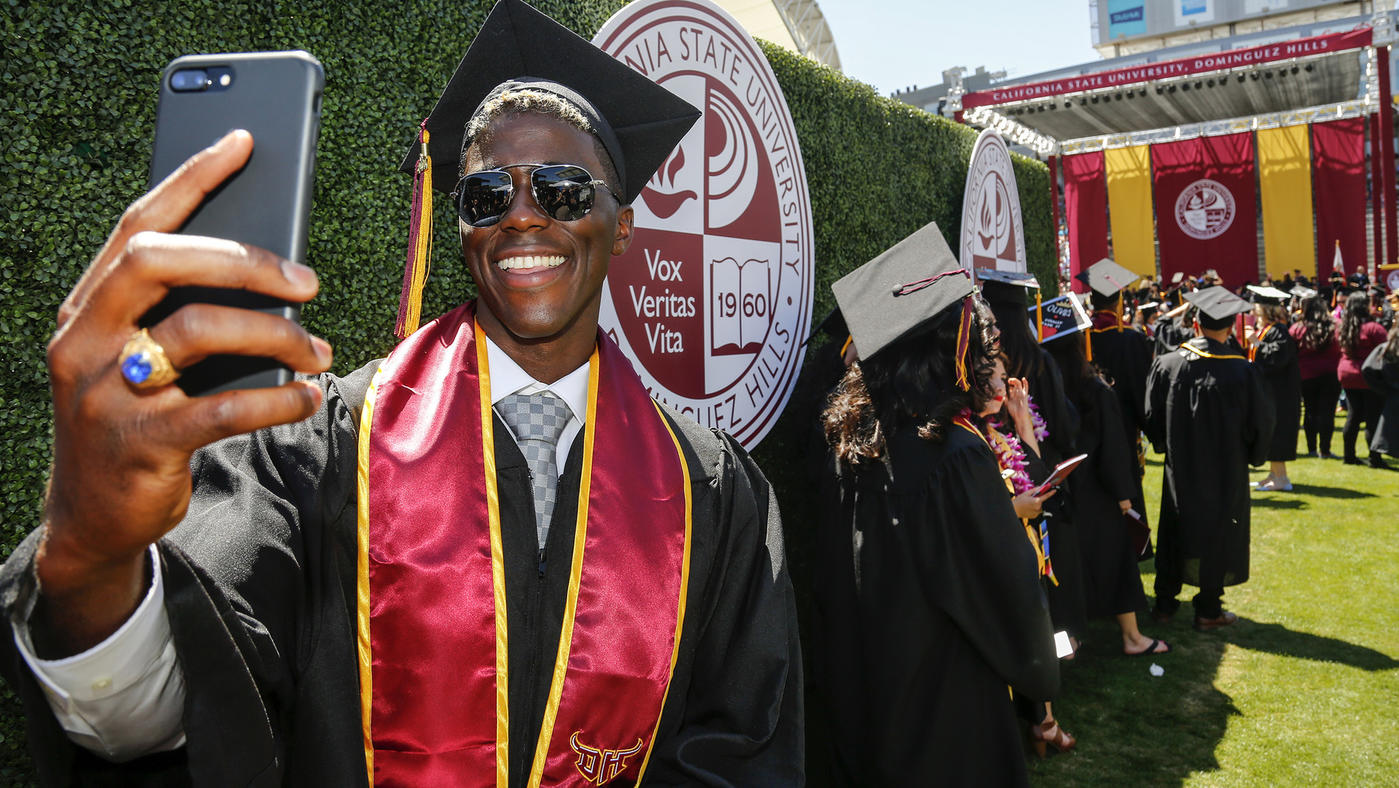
[395,0,701,337]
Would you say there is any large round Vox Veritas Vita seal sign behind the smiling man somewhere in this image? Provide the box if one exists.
[593,0,814,448]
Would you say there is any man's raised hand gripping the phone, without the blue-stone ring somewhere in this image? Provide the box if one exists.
[31,57,332,658]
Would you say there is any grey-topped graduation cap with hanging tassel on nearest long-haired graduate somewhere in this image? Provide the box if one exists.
[831,223,975,391]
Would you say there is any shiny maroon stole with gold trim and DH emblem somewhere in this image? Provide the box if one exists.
[358,304,690,788]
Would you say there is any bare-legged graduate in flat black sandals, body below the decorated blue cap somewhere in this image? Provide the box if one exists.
[1044,327,1171,655]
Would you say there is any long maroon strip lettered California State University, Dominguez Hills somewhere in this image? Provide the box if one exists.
[963,28,1370,111]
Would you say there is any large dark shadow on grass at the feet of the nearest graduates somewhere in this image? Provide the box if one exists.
[1030,615,1238,787]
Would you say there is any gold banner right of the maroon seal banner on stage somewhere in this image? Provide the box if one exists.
[1258,126,1316,279]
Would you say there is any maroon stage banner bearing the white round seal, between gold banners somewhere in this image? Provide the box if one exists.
[1151,132,1258,290]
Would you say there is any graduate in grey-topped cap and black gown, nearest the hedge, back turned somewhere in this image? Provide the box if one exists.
[811,224,1059,787]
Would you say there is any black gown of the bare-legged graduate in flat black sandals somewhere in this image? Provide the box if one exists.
[1069,378,1146,617]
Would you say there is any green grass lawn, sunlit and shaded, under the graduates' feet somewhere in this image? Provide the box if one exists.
[1031,424,1399,785]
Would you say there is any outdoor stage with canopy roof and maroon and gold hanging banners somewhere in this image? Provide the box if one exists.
[949,11,1399,286]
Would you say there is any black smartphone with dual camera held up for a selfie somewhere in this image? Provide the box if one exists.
[140,52,326,396]
